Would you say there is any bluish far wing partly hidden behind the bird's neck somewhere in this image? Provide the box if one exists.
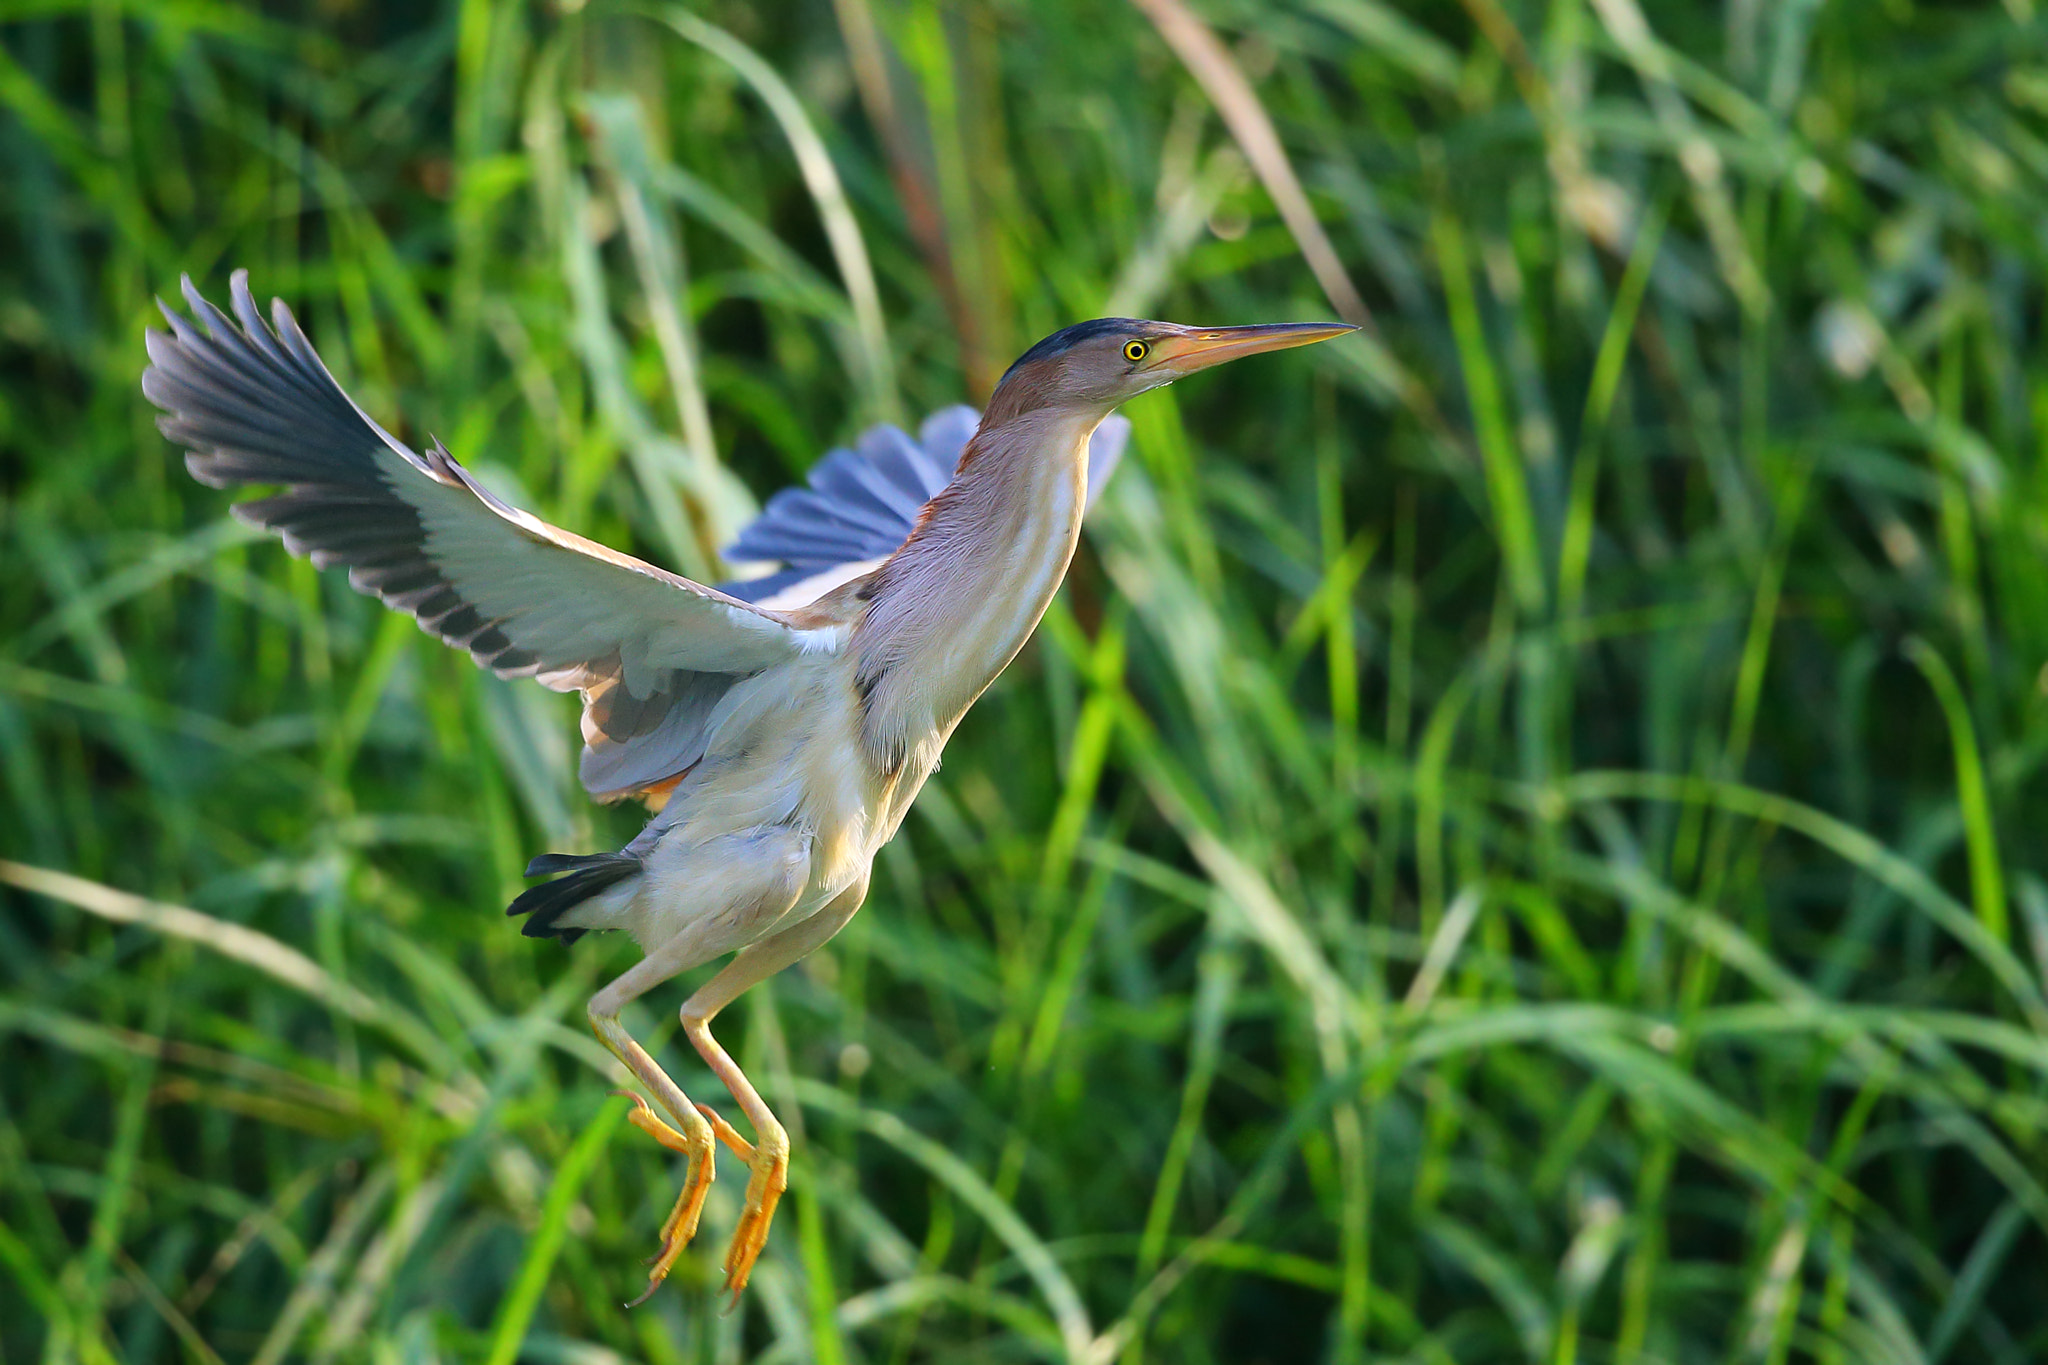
[721,405,1130,610]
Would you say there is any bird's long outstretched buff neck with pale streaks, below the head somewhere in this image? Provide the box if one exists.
[856,403,1104,757]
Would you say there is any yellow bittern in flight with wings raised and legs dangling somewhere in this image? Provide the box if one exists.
[141,272,1352,1304]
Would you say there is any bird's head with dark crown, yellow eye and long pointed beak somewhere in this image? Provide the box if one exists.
[989,317,1358,415]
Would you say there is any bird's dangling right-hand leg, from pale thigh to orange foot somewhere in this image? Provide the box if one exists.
[682,882,868,1306]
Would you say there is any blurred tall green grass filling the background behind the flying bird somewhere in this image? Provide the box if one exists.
[0,0,2048,1365]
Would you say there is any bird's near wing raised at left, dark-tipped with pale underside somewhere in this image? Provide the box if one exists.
[141,270,836,800]
